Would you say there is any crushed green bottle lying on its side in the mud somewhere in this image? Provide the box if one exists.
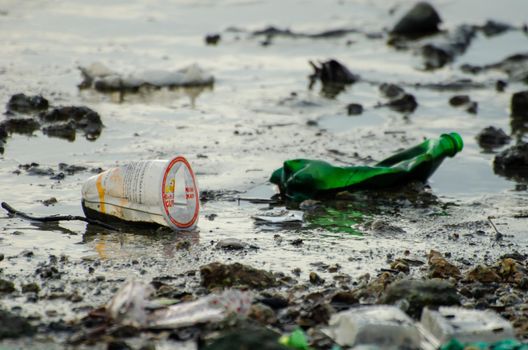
[270,132,464,201]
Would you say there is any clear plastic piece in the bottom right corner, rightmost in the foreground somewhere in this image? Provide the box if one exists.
[421,307,515,343]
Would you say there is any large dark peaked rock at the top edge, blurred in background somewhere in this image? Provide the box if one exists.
[391,2,442,37]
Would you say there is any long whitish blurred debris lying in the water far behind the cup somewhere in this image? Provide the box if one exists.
[79,62,214,91]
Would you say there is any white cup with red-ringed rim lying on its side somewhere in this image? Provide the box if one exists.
[82,156,200,230]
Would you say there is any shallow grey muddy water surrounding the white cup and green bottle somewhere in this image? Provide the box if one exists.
[0,0,528,344]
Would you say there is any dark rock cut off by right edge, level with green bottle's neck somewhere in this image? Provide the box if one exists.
[493,142,528,178]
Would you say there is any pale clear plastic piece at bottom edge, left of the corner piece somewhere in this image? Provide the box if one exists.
[323,305,422,349]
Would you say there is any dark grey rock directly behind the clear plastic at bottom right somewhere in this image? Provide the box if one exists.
[380,279,460,319]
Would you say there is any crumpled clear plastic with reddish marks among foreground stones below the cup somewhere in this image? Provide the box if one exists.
[148,289,252,329]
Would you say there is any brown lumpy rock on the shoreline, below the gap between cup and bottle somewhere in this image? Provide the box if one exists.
[200,262,278,289]
